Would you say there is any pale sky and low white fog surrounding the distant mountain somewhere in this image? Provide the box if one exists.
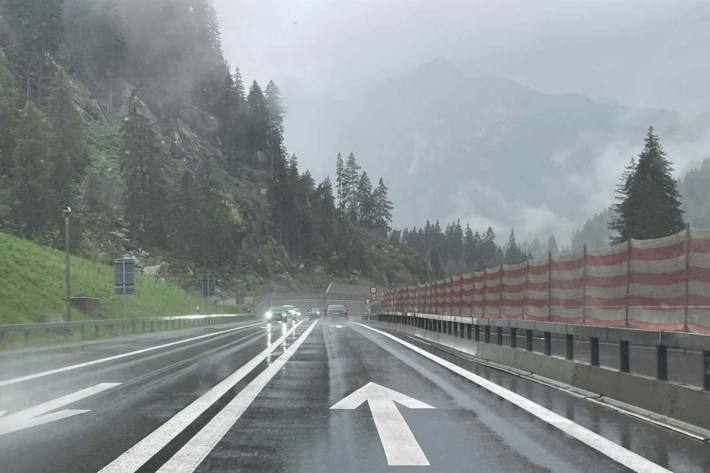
[215,0,710,242]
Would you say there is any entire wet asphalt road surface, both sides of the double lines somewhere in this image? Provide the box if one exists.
[0,321,710,473]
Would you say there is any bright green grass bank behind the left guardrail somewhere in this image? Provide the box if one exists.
[0,233,228,324]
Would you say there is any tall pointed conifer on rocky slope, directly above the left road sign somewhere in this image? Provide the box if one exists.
[121,91,168,245]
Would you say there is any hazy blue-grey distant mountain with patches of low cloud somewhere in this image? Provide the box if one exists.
[286,59,678,242]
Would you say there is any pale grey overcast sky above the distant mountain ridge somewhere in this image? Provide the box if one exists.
[215,0,710,112]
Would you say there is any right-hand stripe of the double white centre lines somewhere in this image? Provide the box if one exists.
[158,320,318,473]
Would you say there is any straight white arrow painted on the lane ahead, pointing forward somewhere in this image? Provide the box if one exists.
[331,383,436,466]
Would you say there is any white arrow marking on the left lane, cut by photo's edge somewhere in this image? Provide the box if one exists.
[0,383,121,435]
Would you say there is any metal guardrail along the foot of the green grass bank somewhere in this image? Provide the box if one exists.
[0,314,254,346]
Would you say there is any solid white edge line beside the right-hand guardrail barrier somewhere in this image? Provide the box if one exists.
[355,322,670,473]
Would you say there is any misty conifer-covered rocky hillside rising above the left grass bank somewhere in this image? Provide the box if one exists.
[0,0,419,284]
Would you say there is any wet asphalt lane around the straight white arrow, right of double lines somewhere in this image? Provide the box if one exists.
[178,322,710,472]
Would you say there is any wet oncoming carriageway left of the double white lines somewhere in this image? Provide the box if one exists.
[0,322,300,473]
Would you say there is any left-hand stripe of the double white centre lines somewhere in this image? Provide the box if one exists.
[100,322,302,473]
